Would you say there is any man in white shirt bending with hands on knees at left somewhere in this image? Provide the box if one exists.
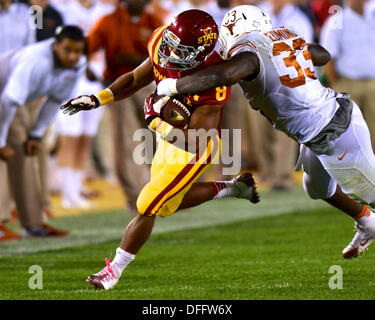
[0,26,86,236]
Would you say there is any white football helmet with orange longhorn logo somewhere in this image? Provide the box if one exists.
[219,5,272,58]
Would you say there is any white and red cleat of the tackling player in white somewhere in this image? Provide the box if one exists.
[342,223,375,259]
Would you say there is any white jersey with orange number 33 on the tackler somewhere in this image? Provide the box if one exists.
[220,28,339,143]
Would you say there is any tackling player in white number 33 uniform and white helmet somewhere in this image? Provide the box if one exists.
[158,5,375,258]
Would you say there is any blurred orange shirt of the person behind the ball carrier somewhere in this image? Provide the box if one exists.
[89,6,163,81]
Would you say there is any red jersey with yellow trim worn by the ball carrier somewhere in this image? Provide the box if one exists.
[147,26,231,111]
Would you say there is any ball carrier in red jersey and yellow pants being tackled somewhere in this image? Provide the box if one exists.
[61,10,259,289]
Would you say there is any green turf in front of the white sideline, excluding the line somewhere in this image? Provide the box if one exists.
[0,202,375,300]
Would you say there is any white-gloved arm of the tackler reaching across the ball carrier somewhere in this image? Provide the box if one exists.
[157,52,260,95]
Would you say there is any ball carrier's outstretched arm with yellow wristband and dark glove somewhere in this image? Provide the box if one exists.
[60,59,153,115]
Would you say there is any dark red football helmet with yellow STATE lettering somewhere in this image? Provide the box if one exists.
[158,9,218,71]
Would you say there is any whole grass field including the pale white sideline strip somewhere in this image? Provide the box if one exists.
[0,188,375,300]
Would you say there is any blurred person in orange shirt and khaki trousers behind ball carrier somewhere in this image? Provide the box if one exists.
[89,0,163,211]
